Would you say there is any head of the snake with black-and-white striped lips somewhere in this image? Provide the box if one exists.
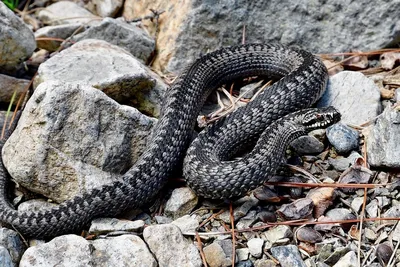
[300,106,341,131]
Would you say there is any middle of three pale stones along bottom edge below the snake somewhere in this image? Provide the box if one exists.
[92,235,157,267]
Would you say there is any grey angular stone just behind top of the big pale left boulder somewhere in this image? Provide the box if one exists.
[72,18,155,63]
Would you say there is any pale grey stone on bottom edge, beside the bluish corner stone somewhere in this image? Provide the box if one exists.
[19,235,92,267]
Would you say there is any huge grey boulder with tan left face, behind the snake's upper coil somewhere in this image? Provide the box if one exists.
[124,0,400,71]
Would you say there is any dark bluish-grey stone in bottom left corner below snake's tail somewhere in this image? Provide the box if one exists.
[0,228,25,266]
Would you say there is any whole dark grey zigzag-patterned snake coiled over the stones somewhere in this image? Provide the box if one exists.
[0,44,339,239]
